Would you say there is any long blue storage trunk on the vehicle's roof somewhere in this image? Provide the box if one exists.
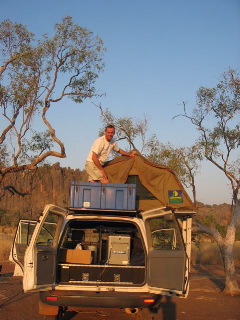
[71,182,136,210]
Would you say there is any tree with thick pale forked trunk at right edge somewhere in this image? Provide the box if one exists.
[176,70,240,294]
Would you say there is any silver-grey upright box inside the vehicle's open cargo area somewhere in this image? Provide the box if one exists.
[107,235,131,266]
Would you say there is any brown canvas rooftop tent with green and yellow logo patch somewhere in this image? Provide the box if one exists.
[104,152,193,210]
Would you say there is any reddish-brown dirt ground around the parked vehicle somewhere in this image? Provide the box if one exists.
[0,262,240,320]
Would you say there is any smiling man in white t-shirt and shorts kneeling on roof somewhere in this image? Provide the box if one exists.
[85,125,136,183]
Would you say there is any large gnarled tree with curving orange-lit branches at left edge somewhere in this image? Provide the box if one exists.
[0,16,105,192]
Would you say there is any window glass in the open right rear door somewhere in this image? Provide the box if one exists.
[149,216,182,250]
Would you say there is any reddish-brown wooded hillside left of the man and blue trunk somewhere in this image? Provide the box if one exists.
[0,163,87,219]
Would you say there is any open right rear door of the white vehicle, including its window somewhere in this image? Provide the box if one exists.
[142,208,192,296]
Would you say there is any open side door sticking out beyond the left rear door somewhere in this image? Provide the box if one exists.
[9,220,37,275]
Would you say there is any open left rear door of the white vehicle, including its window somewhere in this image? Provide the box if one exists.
[23,204,68,292]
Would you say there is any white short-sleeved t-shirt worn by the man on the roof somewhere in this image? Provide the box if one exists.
[86,135,119,165]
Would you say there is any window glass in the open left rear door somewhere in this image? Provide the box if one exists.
[37,213,59,246]
